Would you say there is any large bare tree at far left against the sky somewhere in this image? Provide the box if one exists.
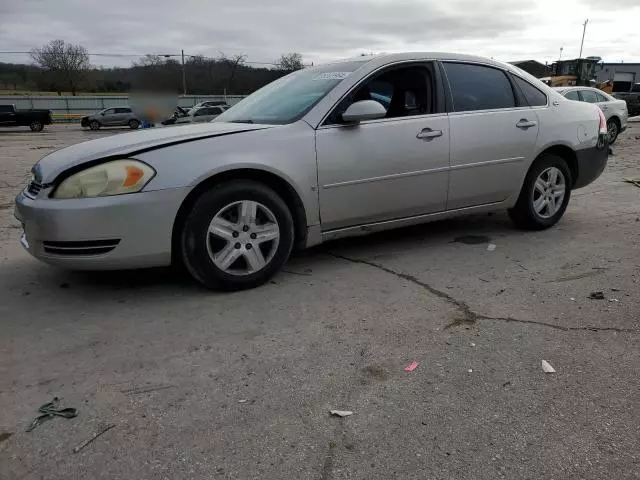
[30,40,89,95]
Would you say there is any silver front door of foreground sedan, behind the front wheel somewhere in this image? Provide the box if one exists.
[316,62,449,230]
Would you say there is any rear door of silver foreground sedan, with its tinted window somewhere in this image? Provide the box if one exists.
[442,62,547,210]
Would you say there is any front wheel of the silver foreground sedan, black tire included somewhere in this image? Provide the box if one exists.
[180,180,295,291]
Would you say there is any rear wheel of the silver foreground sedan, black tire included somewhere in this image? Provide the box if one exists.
[509,154,573,230]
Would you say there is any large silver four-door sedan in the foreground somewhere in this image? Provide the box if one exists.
[15,53,608,290]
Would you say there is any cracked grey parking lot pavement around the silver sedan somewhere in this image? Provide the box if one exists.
[0,124,640,480]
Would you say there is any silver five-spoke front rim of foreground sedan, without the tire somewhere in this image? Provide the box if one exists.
[205,200,280,276]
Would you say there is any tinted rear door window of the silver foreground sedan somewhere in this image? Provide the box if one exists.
[444,63,516,112]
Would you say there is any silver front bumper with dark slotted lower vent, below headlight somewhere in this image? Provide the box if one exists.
[14,188,189,270]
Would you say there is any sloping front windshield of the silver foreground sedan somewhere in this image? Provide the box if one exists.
[215,60,366,124]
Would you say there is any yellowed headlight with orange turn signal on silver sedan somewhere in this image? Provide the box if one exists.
[53,159,156,198]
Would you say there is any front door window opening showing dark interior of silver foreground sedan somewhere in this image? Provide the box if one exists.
[325,65,436,125]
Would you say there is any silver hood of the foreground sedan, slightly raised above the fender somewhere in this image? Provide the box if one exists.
[33,122,273,184]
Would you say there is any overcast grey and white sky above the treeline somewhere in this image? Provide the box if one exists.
[0,0,640,66]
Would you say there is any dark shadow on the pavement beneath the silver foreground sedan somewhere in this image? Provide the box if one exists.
[10,213,526,298]
